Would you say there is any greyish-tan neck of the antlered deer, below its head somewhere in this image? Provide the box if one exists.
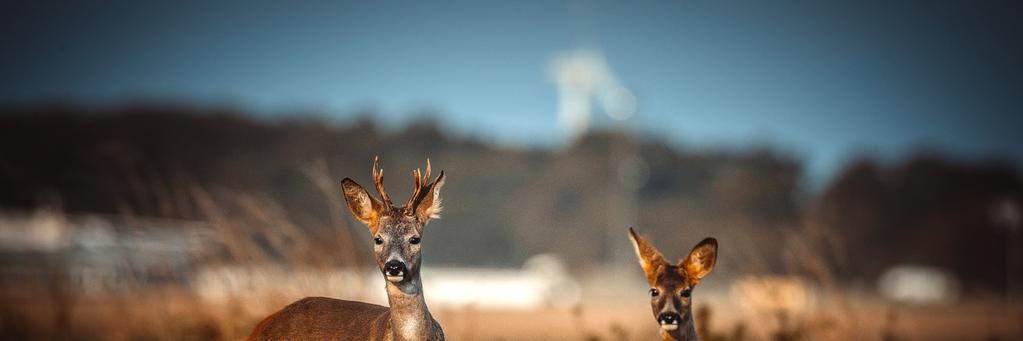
[387,273,434,340]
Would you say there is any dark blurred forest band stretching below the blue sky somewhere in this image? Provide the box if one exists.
[0,102,1023,293]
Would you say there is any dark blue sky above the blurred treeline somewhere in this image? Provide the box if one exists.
[0,1,1023,186]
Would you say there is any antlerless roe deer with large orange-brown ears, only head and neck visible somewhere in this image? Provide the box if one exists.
[629,227,717,341]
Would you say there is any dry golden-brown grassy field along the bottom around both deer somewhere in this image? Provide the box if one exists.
[0,280,1023,340]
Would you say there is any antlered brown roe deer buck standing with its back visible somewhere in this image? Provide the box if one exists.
[249,159,444,340]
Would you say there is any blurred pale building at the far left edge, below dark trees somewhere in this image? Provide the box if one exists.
[0,210,214,294]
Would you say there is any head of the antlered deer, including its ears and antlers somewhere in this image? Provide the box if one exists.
[341,158,444,285]
